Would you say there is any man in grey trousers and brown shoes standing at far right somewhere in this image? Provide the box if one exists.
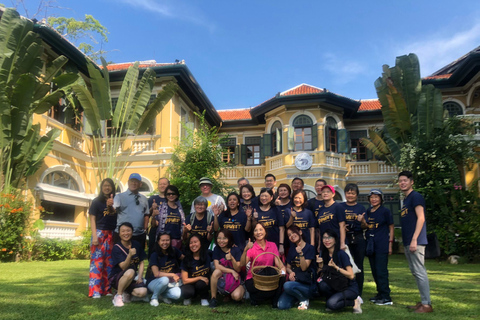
[398,171,433,313]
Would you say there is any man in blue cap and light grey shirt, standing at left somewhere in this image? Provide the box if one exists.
[113,173,149,248]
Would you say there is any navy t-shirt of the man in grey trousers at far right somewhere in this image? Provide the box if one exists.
[401,190,428,246]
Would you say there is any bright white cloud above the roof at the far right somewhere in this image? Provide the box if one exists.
[394,21,480,77]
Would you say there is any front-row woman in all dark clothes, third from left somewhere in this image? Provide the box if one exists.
[180,234,210,307]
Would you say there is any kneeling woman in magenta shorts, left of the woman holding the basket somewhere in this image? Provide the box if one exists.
[210,229,245,308]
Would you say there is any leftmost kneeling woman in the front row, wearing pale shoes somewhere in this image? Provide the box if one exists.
[109,222,147,307]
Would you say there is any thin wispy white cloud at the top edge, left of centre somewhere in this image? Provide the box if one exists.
[120,0,215,32]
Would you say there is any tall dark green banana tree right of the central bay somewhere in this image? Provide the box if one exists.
[360,53,444,165]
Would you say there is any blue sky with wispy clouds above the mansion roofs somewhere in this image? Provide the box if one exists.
[15,0,480,110]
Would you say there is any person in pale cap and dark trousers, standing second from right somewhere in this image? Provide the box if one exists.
[365,189,394,305]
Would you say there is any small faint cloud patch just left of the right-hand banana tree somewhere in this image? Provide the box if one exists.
[323,53,367,85]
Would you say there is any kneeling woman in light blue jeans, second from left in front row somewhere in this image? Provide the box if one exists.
[147,232,183,307]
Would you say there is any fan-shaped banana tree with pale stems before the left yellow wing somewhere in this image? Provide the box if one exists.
[70,58,178,181]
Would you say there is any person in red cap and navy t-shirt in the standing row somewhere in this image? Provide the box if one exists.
[315,184,345,251]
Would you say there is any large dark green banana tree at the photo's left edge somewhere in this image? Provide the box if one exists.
[0,9,78,189]
